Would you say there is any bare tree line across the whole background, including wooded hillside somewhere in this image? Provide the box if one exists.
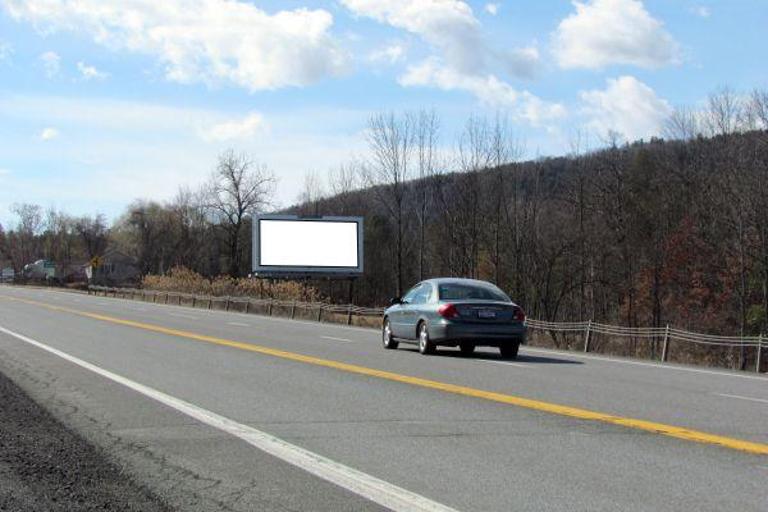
[0,88,768,360]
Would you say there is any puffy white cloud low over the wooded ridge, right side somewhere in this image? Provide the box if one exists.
[579,76,672,141]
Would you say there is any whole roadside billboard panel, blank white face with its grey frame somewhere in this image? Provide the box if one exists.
[252,215,363,276]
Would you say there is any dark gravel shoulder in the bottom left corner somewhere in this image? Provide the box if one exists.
[0,373,171,512]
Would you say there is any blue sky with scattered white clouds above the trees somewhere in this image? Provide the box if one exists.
[0,0,768,226]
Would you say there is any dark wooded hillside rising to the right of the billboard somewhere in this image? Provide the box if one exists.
[291,131,768,334]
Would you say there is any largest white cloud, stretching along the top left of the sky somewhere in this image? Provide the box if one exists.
[0,0,346,91]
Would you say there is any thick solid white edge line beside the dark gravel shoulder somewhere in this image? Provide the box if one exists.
[0,326,457,512]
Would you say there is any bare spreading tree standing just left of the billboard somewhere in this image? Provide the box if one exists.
[206,149,276,276]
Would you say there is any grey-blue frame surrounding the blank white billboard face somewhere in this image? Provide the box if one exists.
[251,214,365,279]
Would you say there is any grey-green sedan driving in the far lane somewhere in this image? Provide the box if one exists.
[382,278,527,359]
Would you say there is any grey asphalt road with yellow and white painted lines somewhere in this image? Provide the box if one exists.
[0,287,768,512]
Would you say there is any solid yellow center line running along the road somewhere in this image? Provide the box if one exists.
[0,296,768,455]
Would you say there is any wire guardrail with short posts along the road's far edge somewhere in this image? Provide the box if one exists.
[88,286,768,372]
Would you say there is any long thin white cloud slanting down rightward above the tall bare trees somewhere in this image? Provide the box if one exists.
[400,61,566,126]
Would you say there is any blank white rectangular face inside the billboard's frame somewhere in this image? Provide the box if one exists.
[259,219,358,269]
